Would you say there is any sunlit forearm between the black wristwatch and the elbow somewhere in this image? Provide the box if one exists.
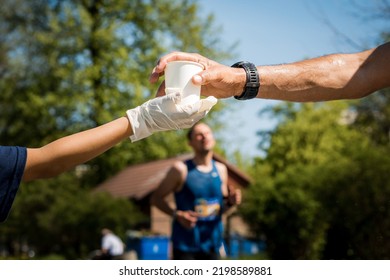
[258,51,370,102]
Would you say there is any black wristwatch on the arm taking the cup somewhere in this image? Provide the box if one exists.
[232,61,260,100]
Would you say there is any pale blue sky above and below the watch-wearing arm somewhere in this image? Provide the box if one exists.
[197,0,389,158]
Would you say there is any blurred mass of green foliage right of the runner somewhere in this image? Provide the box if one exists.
[242,102,390,259]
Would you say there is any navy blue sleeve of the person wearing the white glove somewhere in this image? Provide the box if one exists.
[0,146,27,222]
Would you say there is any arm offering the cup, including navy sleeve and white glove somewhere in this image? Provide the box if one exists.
[0,92,216,222]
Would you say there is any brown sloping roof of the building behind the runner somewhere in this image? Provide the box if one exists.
[95,153,250,200]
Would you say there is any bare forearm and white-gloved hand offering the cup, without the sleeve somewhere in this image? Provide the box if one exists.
[23,93,216,181]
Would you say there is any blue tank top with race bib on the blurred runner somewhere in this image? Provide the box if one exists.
[172,160,223,253]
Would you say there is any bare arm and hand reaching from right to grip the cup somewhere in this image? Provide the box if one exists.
[150,43,390,102]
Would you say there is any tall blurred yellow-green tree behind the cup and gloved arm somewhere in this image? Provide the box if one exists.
[0,0,227,185]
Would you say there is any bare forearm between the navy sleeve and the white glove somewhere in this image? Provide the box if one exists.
[23,117,133,181]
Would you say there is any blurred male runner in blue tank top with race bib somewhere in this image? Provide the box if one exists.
[151,123,241,260]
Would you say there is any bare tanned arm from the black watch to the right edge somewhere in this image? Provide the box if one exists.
[257,44,390,102]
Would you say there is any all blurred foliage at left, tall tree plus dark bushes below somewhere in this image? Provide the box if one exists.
[0,0,233,258]
